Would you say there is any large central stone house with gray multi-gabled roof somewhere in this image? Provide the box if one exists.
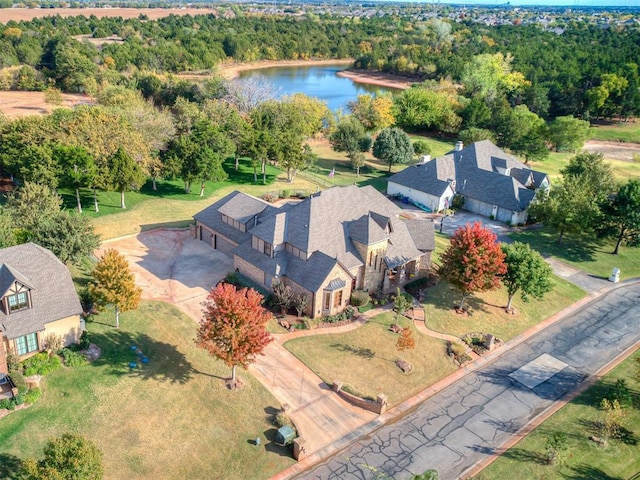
[194,186,435,318]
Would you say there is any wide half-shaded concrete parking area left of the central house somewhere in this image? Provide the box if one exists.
[97,230,233,322]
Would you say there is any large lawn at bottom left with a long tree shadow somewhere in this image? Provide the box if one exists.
[0,302,294,479]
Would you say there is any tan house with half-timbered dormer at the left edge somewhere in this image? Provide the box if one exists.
[0,243,82,383]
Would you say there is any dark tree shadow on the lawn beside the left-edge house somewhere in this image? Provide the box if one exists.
[91,328,194,384]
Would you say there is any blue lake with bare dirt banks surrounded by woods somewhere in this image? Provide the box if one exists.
[237,65,396,111]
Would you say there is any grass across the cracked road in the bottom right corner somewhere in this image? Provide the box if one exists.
[474,352,640,480]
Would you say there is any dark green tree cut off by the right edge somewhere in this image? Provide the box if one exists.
[599,179,640,255]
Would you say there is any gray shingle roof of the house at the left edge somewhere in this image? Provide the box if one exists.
[0,243,82,339]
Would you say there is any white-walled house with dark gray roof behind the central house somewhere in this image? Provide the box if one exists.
[387,140,549,225]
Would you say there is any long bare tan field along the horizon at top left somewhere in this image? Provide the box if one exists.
[0,8,218,23]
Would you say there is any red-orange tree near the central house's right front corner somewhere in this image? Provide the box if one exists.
[438,222,507,309]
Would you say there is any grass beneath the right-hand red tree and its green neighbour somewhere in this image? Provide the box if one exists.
[423,277,585,341]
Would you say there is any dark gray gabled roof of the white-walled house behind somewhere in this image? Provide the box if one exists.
[389,140,547,211]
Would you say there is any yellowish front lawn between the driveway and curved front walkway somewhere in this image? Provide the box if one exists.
[285,314,456,405]
